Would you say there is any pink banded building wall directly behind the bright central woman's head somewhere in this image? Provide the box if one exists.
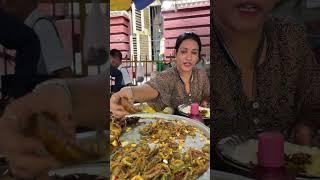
[162,1,210,58]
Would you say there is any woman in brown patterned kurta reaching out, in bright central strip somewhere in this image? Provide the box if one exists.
[110,32,210,117]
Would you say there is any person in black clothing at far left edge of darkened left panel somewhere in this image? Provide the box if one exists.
[0,6,40,98]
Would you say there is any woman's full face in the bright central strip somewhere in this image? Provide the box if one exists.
[176,39,199,72]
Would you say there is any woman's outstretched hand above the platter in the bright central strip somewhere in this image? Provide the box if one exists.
[110,87,134,118]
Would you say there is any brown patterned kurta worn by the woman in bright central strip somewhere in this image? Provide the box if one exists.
[146,67,210,111]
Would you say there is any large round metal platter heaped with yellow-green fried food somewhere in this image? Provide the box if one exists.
[110,113,210,180]
